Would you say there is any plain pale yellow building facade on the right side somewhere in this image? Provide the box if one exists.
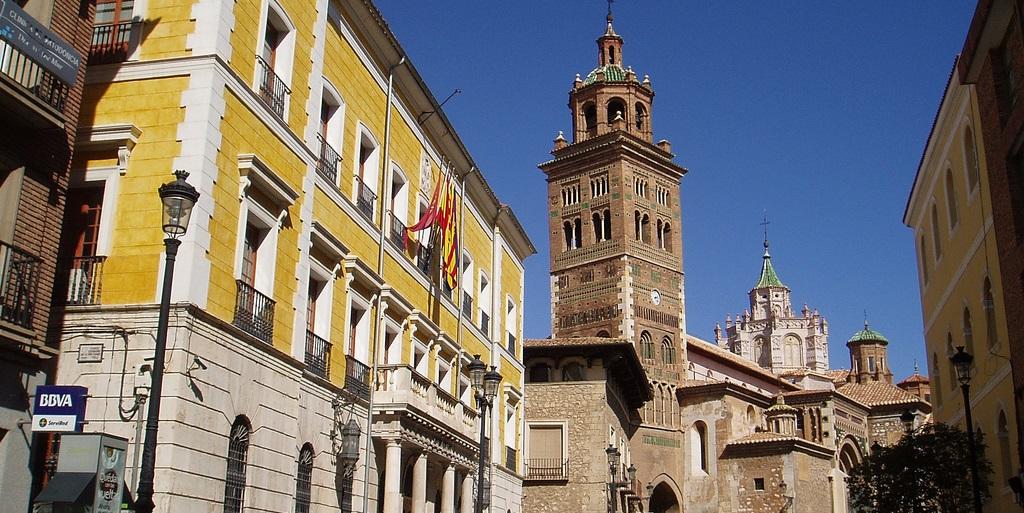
[903,66,1017,512]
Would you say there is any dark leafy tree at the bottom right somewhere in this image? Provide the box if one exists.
[847,424,992,513]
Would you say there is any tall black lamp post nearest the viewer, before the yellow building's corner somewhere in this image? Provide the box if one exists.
[135,170,199,513]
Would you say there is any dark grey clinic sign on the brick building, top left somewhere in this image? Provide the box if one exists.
[0,0,82,85]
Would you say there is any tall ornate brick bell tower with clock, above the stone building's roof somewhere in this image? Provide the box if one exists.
[540,12,686,384]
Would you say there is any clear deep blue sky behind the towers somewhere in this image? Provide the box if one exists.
[377,0,975,379]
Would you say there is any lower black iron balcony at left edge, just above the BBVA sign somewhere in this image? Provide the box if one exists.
[0,242,42,330]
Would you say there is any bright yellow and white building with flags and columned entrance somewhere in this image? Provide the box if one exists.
[58,0,535,513]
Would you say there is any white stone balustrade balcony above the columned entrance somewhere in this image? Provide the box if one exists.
[374,364,480,439]
